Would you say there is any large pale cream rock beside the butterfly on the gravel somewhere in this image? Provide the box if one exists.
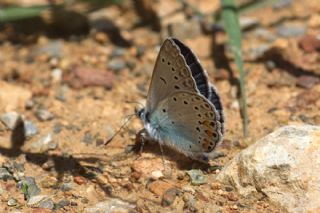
[217,125,320,212]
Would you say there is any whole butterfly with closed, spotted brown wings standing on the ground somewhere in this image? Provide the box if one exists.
[137,38,224,163]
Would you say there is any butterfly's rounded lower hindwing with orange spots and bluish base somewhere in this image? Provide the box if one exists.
[151,91,223,160]
